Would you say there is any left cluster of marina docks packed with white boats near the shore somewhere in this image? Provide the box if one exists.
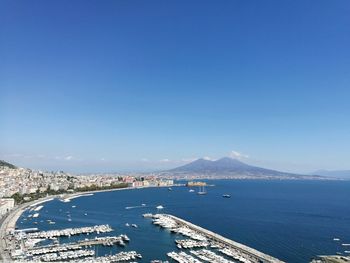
[6,225,138,262]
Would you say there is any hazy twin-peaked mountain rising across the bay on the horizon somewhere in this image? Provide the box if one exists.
[166,157,319,179]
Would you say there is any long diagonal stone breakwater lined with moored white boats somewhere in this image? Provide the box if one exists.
[146,214,284,263]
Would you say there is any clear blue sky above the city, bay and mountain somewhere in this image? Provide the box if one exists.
[0,0,350,172]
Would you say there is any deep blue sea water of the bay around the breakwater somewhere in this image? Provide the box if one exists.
[17,180,350,263]
